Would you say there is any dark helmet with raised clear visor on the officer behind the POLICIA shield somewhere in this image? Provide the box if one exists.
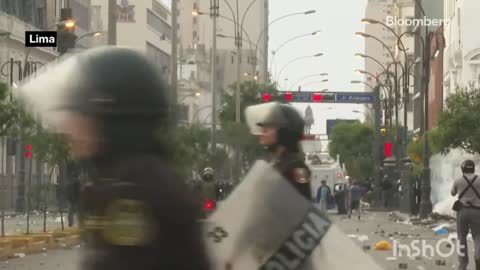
[245,102,305,152]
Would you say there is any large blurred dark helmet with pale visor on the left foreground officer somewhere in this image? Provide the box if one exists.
[21,47,169,160]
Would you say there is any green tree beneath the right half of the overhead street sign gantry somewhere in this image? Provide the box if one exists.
[328,122,374,179]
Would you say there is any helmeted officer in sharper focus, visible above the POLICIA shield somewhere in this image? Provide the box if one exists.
[245,102,312,200]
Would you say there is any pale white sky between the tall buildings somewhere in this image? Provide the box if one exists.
[269,0,367,134]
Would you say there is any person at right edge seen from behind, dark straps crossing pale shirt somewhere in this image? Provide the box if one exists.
[451,160,480,270]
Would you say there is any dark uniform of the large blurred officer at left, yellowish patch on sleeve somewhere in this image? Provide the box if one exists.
[81,155,208,270]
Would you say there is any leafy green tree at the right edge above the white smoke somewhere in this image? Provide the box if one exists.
[432,84,480,154]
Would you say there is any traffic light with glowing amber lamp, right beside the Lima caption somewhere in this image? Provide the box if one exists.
[57,8,77,54]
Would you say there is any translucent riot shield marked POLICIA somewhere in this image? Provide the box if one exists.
[205,161,381,270]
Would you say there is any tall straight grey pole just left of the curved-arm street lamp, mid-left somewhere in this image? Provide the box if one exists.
[210,0,219,155]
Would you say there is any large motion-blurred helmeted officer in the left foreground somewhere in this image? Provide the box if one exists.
[21,47,209,270]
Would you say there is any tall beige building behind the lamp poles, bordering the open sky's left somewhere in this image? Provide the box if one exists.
[179,0,268,89]
